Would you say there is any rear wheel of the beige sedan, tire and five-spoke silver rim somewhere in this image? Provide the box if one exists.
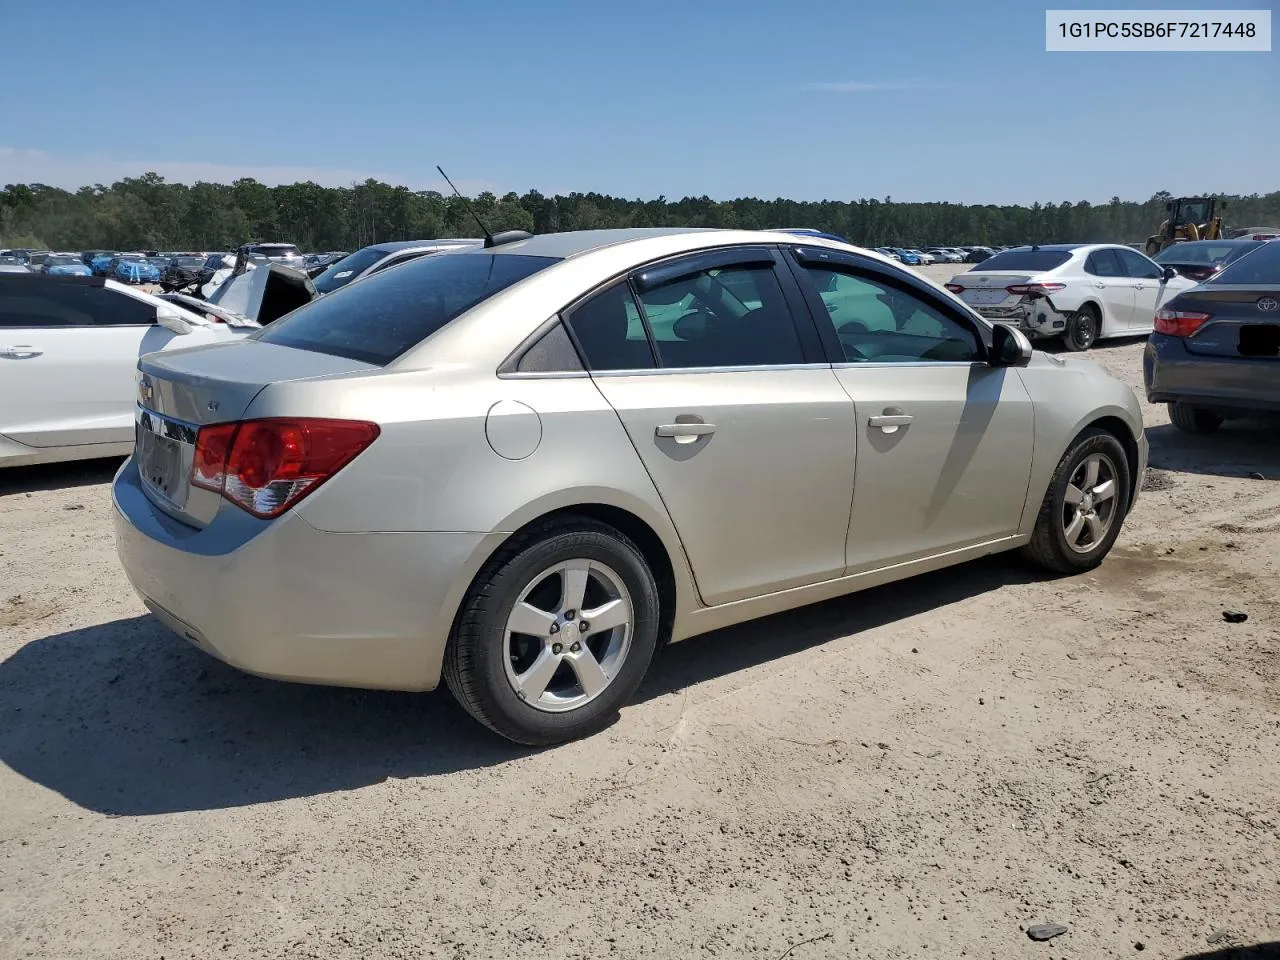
[444,517,659,746]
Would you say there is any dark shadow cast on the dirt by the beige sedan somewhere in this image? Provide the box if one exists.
[0,557,1034,817]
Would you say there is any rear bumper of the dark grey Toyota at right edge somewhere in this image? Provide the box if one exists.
[1142,333,1280,413]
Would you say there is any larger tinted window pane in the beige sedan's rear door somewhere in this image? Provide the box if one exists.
[629,265,805,367]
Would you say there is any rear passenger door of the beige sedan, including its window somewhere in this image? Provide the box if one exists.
[566,247,855,604]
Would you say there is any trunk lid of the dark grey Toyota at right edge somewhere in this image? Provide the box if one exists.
[1167,284,1280,362]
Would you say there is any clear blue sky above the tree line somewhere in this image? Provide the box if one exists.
[0,0,1280,204]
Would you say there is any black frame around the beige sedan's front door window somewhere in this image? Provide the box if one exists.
[787,244,992,369]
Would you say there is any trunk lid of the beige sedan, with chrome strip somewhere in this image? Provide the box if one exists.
[134,339,379,527]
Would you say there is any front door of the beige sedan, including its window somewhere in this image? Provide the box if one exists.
[778,247,1034,573]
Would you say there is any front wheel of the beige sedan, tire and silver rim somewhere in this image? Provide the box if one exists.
[1023,428,1133,573]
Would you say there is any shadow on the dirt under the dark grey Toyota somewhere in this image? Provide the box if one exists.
[1147,420,1280,480]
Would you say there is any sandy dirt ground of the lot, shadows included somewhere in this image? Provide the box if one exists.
[0,268,1280,960]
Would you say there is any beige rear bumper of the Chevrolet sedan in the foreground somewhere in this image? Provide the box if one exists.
[111,458,502,690]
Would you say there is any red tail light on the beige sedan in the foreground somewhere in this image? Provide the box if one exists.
[191,417,379,520]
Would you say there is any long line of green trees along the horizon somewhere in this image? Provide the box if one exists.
[0,173,1280,251]
